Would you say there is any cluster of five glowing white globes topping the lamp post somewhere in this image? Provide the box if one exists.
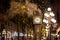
[43,7,56,23]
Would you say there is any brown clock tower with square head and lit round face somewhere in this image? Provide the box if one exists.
[33,11,42,40]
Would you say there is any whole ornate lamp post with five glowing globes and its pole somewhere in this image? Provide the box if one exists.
[43,7,56,39]
